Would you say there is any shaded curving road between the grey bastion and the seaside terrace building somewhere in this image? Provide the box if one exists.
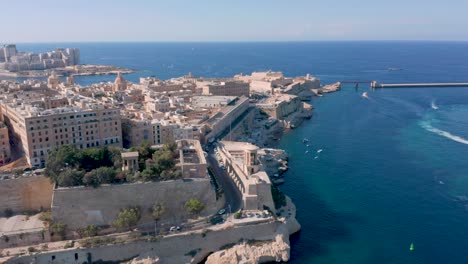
[207,146,242,213]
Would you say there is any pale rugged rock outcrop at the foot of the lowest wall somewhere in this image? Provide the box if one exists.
[206,234,290,264]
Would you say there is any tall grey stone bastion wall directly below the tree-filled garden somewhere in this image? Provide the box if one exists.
[52,179,219,229]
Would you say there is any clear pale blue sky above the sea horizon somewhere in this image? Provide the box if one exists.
[0,0,468,43]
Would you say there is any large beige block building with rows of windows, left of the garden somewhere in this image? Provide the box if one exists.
[0,102,122,167]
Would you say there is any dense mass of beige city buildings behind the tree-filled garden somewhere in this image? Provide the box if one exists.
[0,68,317,167]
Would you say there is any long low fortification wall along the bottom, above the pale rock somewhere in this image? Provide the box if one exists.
[6,222,282,264]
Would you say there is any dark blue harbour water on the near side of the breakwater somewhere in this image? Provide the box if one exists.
[280,87,468,263]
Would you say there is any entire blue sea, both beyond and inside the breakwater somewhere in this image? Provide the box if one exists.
[9,42,468,264]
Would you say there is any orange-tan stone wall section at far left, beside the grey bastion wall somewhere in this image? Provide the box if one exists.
[0,176,53,214]
